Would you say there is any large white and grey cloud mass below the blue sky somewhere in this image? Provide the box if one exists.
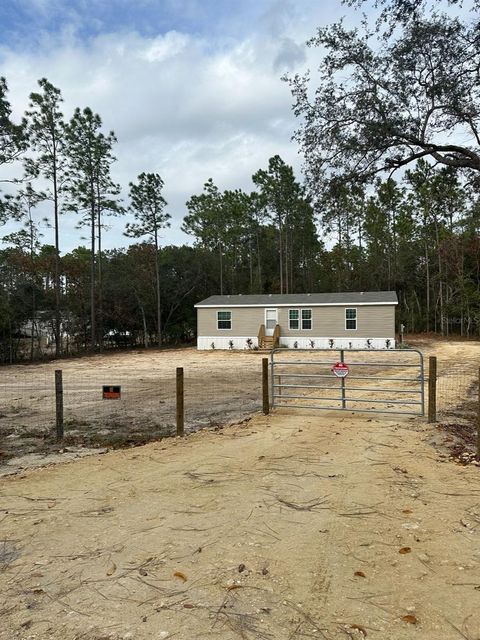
[0,3,334,250]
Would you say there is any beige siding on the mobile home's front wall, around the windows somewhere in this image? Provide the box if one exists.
[197,305,395,338]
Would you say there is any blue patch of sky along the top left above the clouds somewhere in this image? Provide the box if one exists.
[0,0,270,49]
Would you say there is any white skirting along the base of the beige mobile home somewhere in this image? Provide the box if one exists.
[197,336,395,350]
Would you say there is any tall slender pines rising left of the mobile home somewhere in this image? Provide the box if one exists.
[0,78,170,360]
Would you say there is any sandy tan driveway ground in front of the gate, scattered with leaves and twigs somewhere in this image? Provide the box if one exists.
[0,342,480,640]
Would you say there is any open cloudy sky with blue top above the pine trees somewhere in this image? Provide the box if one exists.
[0,0,352,251]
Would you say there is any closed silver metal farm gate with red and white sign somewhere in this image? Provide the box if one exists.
[270,348,425,415]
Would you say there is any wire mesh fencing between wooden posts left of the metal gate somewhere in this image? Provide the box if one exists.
[0,358,262,461]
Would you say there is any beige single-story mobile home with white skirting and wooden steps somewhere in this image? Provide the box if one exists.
[195,291,398,349]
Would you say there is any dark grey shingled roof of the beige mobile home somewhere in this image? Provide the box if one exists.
[195,291,398,307]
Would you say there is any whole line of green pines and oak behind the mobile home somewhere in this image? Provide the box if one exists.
[0,0,480,362]
